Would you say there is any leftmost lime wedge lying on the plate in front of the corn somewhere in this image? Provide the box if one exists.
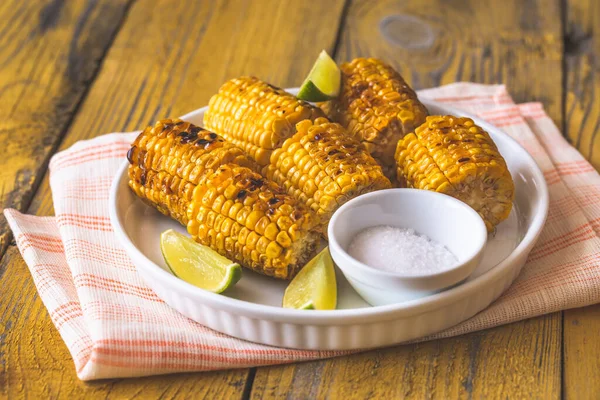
[160,229,242,293]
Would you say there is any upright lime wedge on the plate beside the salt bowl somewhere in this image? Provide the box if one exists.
[283,247,337,310]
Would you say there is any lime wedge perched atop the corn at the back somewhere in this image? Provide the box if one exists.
[297,50,341,102]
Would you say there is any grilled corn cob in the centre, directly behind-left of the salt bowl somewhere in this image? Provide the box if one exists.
[263,118,391,234]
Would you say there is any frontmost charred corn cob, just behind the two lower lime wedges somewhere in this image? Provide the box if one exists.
[187,164,320,279]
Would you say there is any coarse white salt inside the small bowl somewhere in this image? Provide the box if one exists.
[348,225,458,275]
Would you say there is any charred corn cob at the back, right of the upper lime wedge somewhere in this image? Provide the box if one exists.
[320,58,427,178]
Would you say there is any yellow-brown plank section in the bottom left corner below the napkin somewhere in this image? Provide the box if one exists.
[0,246,248,399]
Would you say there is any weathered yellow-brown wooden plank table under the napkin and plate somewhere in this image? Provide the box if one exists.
[0,0,600,399]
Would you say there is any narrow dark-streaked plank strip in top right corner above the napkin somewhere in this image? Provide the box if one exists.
[564,0,600,169]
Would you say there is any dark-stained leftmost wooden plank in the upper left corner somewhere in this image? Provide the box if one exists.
[0,0,129,256]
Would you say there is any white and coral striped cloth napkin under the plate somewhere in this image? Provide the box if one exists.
[4,83,600,380]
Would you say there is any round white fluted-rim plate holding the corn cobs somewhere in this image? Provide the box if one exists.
[109,90,548,350]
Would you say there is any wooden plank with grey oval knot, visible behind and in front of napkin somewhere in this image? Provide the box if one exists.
[253,0,562,398]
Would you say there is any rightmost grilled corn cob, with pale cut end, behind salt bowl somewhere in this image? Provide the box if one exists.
[396,116,515,231]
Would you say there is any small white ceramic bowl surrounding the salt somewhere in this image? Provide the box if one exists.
[328,189,487,306]
